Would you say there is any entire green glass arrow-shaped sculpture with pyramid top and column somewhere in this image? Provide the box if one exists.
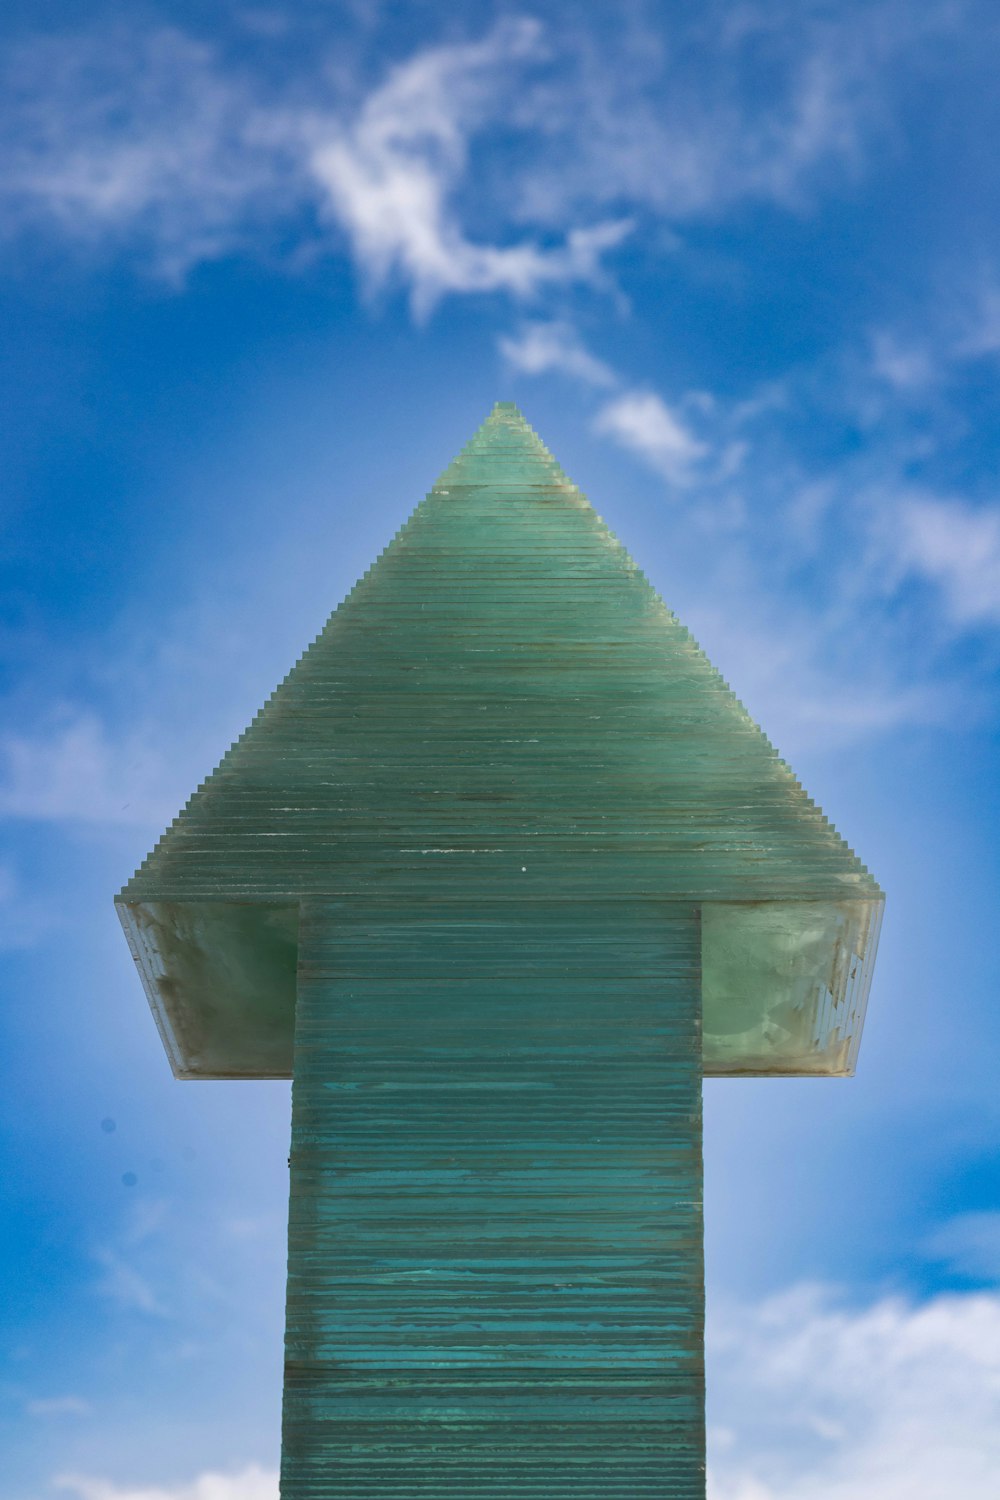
[118,404,882,1500]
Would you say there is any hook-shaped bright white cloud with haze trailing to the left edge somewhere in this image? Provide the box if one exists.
[0,20,628,312]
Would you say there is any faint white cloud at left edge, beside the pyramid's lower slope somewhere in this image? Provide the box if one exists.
[0,710,177,825]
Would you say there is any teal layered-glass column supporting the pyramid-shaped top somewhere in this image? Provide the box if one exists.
[282,902,705,1500]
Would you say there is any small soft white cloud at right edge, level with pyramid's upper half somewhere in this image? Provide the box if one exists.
[886,497,1000,626]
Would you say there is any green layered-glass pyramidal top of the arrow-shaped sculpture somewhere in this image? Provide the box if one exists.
[118,402,880,1076]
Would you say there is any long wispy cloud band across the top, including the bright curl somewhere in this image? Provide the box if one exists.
[0,17,899,304]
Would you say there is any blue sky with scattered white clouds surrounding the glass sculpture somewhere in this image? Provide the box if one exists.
[0,0,1000,1500]
